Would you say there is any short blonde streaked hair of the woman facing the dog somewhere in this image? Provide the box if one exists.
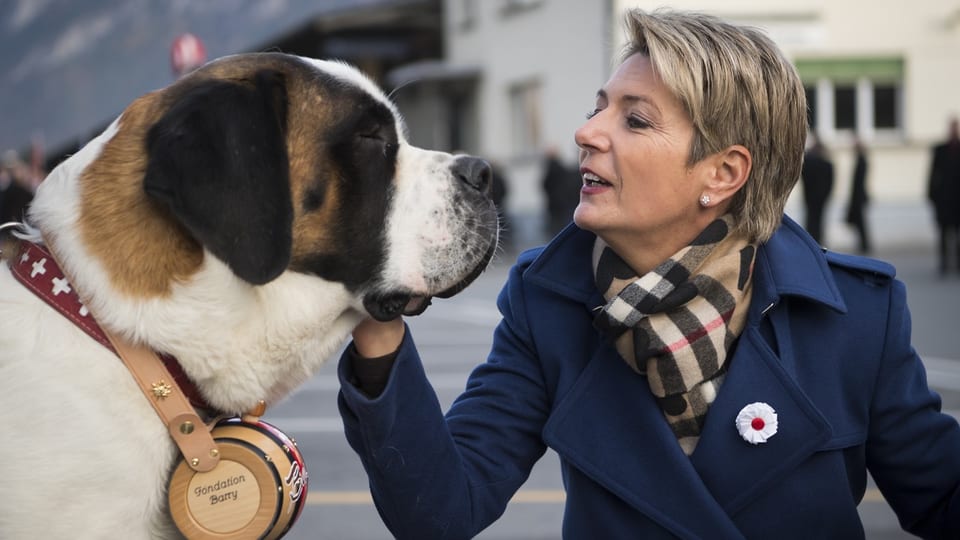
[622,9,807,242]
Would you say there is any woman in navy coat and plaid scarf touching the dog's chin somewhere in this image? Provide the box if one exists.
[340,11,960,539]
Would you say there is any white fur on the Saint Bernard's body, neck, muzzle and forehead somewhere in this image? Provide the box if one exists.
[0,56,489,539]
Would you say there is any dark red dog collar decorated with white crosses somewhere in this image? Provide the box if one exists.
[10,241,212,411]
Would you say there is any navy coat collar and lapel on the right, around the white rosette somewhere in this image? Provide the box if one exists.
[691,218,846,515]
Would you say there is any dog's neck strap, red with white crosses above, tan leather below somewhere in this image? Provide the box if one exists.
[10,241,220,472]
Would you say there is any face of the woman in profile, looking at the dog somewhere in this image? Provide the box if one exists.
[574,54,709,271]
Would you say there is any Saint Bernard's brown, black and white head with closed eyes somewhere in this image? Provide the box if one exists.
[44,53,497,320]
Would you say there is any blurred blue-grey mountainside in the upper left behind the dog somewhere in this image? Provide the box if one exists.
[0,0,439,159]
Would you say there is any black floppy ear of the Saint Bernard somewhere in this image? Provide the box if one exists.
[144,70,293,285]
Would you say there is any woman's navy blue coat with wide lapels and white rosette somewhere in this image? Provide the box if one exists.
[340,218,960,540]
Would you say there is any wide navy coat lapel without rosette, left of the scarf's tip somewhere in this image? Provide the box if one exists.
[543,346,742,538]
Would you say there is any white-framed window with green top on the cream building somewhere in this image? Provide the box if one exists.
[796,58,904,137]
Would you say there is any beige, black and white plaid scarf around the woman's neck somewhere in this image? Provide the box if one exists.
[593,215,756,456]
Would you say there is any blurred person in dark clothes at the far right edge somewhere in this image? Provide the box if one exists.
[927,117,960,276]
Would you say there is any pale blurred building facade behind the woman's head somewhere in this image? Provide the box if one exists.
[394,0,960,248]
